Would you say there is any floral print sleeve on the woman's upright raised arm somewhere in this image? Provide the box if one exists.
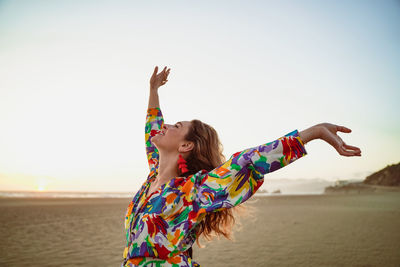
[145,108,164,172]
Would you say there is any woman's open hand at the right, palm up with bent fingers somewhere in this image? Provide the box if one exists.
[316,123,361,157]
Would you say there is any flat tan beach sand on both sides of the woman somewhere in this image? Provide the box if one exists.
[0,192,400,267]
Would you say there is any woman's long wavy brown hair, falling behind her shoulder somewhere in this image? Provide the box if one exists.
[181,119,254,254]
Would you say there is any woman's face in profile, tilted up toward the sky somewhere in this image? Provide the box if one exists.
[152,121,191,152]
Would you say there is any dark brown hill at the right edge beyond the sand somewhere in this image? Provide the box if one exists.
[324,163,400,194]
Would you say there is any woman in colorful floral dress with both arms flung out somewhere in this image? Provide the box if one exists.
[122,66,361,266]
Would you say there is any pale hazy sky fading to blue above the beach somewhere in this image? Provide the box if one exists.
[0,0,400,192]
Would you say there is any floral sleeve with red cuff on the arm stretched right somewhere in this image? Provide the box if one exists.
[196,130,307,213]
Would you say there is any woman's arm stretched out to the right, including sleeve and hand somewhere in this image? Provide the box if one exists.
[189,123,361,220]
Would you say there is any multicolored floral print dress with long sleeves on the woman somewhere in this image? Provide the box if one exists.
[121,108,307,267]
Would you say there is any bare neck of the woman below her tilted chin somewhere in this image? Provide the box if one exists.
[156,153,179,184]
